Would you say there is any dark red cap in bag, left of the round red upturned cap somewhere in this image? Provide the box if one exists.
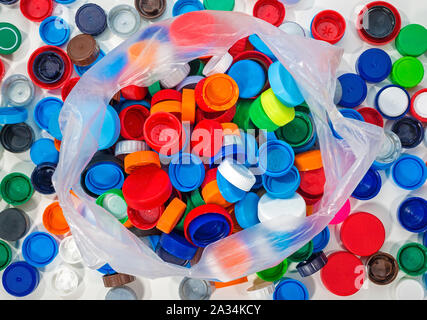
[119,104,150,140]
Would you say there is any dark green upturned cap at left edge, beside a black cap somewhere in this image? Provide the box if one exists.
[0,172,34,206]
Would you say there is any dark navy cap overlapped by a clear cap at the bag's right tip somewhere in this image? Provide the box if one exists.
[391,117,424,149]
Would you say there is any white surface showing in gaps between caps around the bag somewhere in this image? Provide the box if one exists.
[0,0,427,299]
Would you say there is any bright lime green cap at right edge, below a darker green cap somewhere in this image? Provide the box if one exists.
[391,57,424,88]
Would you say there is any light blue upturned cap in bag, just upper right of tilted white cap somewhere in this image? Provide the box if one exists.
[258,140,295,177]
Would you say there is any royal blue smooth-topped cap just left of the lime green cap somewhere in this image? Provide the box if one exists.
[356,48,392,83]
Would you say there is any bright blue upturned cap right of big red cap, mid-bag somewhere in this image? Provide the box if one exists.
[169,153,205,192]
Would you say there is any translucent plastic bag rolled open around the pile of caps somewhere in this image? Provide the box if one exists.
[53,11,383,281]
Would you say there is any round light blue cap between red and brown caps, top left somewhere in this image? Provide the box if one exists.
[39,16,70,46]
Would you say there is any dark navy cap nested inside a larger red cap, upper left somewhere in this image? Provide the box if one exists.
[33,51,65,84]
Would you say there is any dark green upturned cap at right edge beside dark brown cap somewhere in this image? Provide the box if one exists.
[397,242,427,276]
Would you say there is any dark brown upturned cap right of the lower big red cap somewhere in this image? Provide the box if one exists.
[366,251,399,285]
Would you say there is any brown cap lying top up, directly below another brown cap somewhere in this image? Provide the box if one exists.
[67,34,100,67]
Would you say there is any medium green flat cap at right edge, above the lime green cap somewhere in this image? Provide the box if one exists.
[395,24,427,57]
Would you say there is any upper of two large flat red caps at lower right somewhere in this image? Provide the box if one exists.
[340,212,385,257]
